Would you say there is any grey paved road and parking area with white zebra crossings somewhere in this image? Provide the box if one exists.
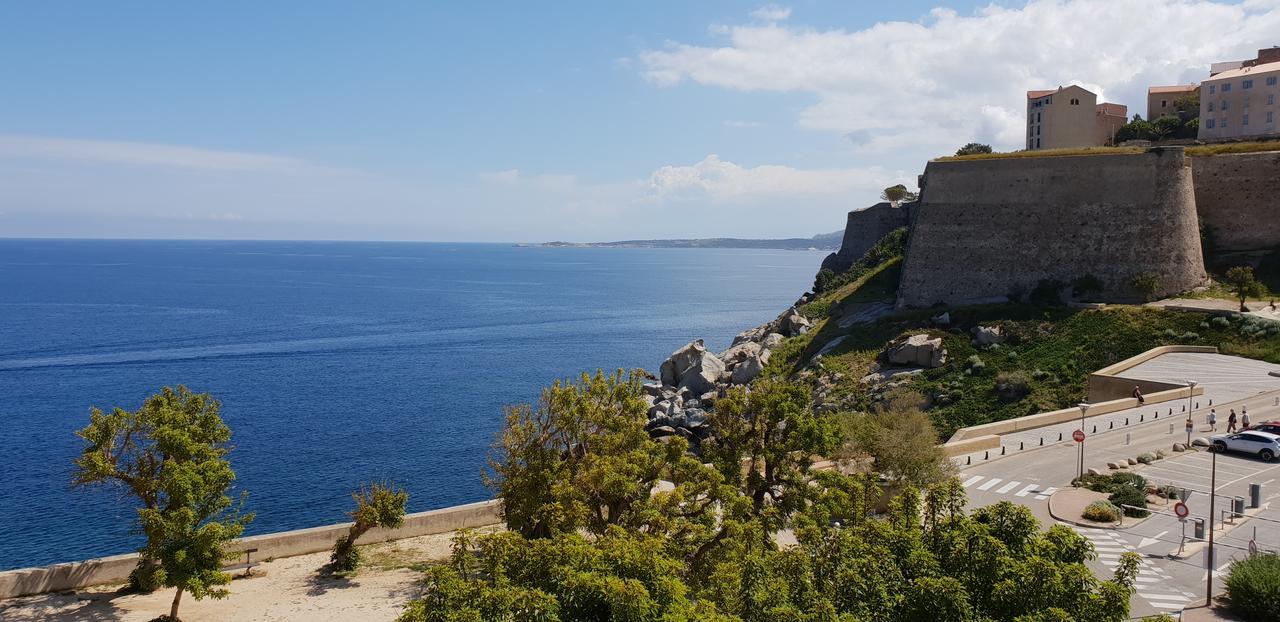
[956,355,1280,617]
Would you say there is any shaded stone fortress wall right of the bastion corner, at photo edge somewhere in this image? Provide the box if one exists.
[1192,151,1280,252]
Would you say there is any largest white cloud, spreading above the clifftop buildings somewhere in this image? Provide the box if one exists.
[639,0,1280,152]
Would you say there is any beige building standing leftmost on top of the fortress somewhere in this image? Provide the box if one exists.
[1027,84,1128,150]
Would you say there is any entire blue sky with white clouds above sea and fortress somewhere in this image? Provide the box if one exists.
[0,0,1280,242]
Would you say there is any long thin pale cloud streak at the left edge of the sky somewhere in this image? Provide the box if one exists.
[0,134,320,173]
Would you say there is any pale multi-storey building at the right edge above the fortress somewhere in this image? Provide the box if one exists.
[1198,47,1280,141]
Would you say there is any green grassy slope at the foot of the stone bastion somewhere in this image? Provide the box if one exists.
[769,262,1280,438]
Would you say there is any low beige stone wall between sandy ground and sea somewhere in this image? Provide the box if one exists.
[0,500,502,599]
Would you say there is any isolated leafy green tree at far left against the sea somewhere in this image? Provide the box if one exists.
[73,385,252,621]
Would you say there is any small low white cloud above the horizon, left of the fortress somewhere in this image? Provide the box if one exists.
[649,154,902,202]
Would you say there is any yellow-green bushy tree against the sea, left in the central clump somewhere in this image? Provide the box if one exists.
[485,371,728,552]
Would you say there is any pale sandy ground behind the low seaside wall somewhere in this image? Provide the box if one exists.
[0,534,499,622]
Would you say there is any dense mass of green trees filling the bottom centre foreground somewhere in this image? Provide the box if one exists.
[401,372,1138,622]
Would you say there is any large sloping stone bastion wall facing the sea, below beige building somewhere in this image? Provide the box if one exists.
[899,147,1206,307]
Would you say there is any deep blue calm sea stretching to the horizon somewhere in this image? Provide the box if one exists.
[0,239,822,568]
